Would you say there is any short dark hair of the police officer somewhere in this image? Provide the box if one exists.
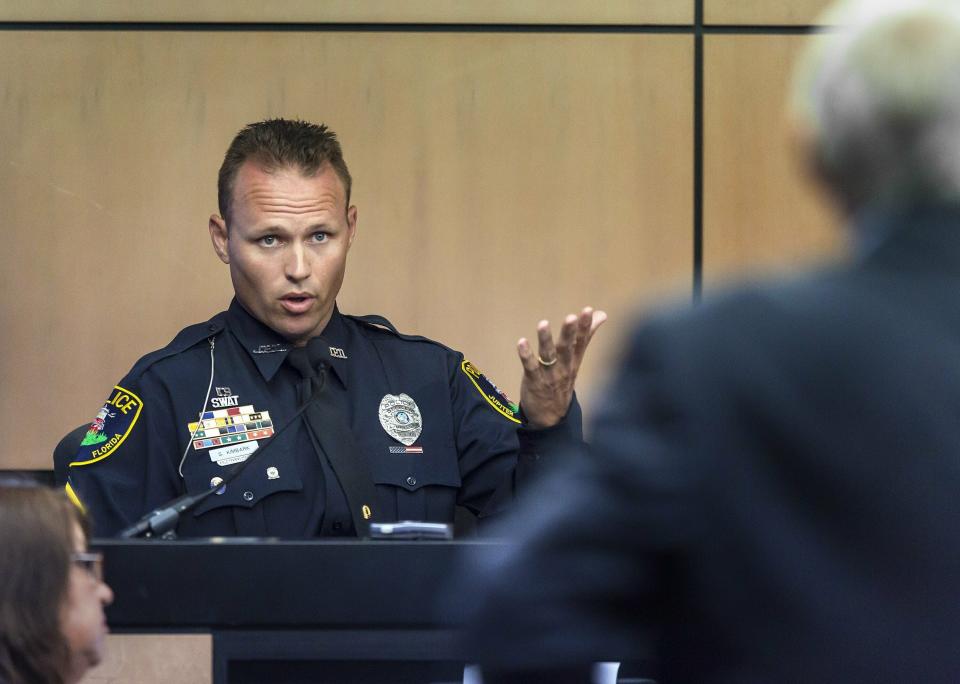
[217,119,352,222]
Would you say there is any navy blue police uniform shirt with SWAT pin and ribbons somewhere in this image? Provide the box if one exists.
[68,300,581,538]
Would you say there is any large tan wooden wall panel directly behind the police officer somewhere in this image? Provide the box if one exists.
[0,31,693,467]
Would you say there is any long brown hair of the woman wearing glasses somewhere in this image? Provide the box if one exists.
[0,482,88,684]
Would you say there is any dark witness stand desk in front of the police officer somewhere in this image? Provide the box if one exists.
[93,539,497,684]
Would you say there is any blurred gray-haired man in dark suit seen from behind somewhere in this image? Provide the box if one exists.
[464,0,960,683]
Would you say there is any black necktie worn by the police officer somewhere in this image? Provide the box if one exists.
[287,338,376,537]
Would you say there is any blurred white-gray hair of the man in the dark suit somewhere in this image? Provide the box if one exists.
[793,0,960,211]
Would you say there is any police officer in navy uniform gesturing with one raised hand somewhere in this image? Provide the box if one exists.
[67,119,606,537]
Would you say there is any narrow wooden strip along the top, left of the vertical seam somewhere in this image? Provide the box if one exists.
[0,0,693,24]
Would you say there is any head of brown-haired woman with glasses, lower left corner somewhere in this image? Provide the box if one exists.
[0,483,113,684]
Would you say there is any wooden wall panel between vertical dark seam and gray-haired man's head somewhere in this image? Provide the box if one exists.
[704,35,842,285]
